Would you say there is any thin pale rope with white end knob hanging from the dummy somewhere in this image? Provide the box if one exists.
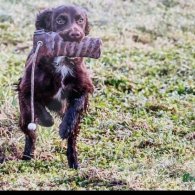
[28,41,43,131]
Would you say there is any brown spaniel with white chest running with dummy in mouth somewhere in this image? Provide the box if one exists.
[18,6,94,169]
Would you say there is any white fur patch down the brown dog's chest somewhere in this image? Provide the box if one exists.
[53,56,74,103]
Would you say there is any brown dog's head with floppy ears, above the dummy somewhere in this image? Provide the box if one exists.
[35,6,89,41]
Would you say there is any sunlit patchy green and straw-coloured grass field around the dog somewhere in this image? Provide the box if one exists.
[0,0,195,190]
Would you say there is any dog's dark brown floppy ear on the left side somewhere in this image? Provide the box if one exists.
[35,9,53,31]
